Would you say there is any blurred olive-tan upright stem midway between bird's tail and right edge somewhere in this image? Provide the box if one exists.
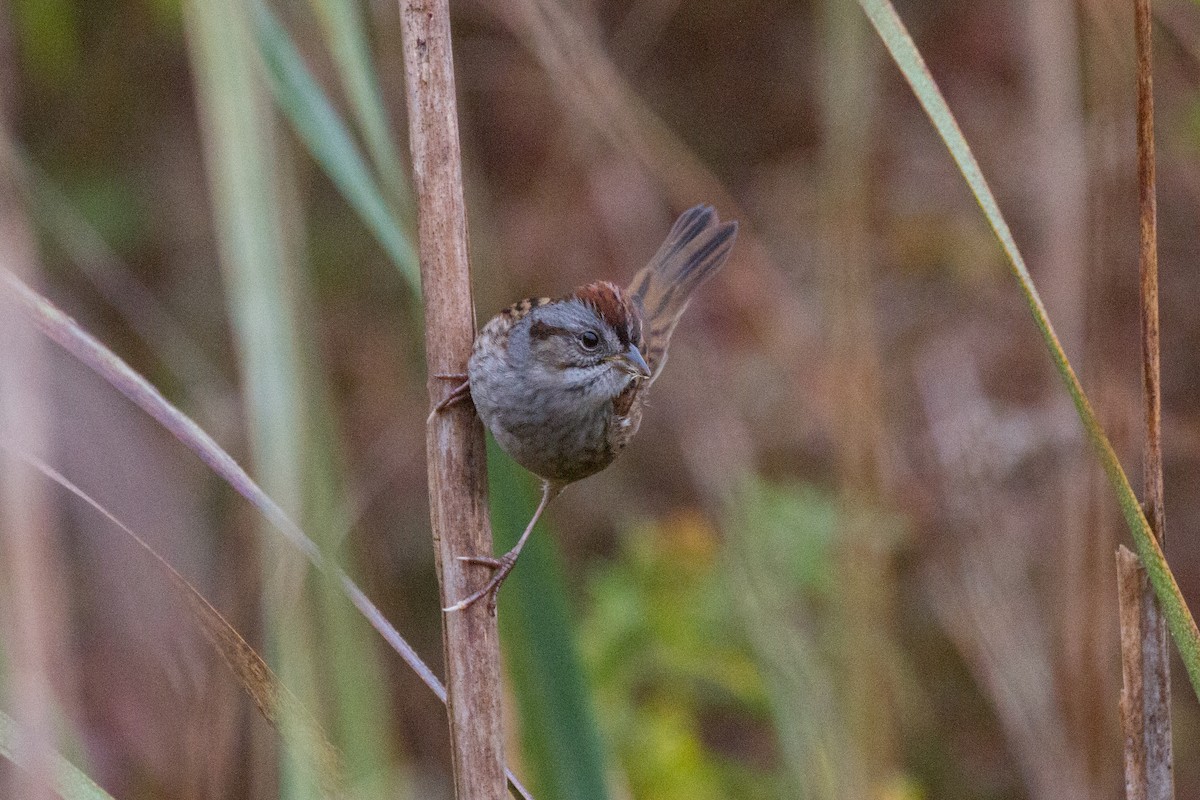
[816,0,902,796]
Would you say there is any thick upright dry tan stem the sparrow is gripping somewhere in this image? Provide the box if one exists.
[400,0,505,800]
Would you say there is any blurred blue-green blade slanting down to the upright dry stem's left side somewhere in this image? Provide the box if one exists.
[252,1,420,287]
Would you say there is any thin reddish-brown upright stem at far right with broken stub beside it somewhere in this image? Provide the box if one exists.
[1121,0,1175,800]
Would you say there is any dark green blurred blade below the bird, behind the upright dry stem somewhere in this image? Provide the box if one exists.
[487,439,608,800]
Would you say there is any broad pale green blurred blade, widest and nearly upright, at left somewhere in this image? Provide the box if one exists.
[186,0,324,800]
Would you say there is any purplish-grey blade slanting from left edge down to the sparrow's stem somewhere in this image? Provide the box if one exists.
[0,269,530,800]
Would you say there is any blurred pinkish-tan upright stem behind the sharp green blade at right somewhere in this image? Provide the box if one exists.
[1020,0,1104,772]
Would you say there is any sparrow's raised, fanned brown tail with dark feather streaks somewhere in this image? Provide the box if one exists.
[629,205,738,381]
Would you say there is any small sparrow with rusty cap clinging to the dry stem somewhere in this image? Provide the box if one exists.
[433,205,738,613]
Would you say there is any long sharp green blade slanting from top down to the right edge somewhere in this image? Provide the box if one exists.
[859,0,1200,697]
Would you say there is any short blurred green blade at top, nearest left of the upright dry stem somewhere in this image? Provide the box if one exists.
[312,0,415,217]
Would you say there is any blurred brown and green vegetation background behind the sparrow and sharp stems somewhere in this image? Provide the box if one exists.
[0,0,1200,800]
